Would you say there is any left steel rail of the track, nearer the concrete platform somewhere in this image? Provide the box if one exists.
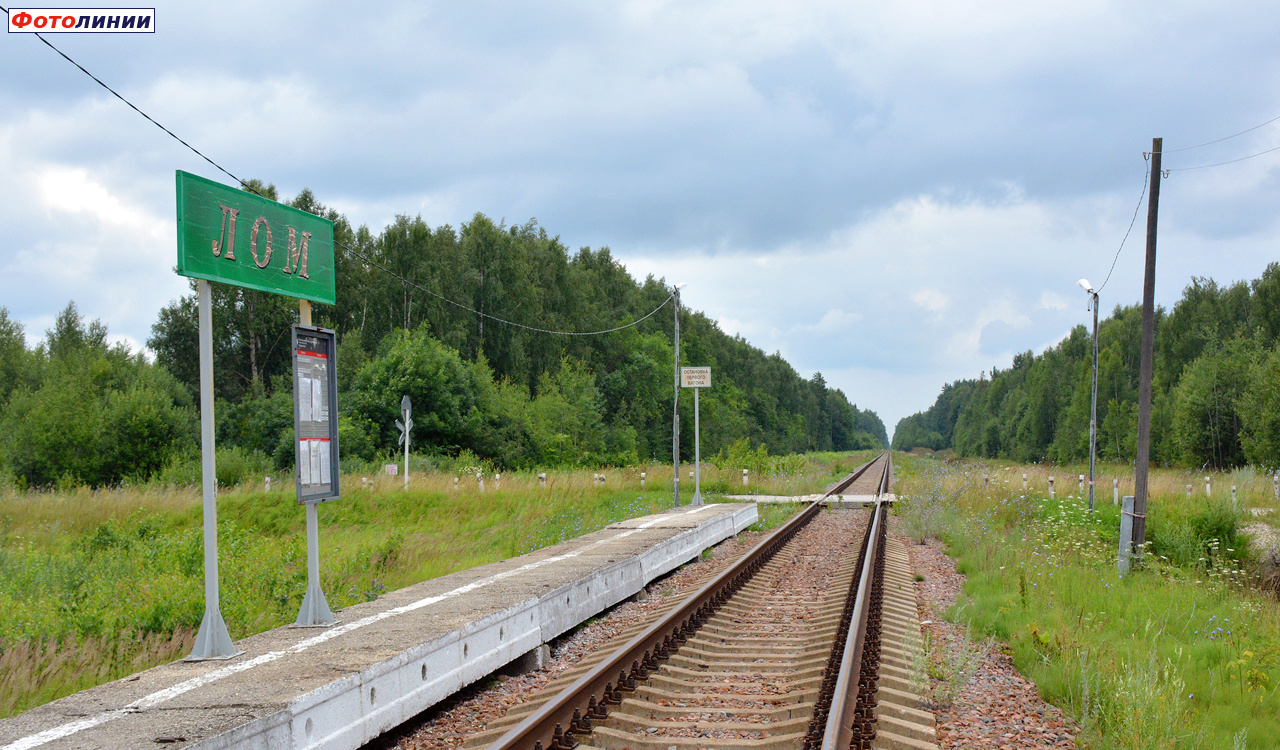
[489,457,879,750]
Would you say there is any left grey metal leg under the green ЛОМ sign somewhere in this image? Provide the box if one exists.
[187,279,243,662]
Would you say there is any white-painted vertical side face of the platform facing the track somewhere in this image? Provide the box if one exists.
[188,506,759,750]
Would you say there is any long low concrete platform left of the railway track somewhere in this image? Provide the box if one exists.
[0,503,756,750]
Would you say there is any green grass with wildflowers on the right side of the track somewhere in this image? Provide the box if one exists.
[897,459,1280,750]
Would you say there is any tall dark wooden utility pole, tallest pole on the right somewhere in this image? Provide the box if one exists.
[1133,138,1164,560]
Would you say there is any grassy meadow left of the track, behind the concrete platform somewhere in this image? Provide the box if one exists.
[0,453,865,717]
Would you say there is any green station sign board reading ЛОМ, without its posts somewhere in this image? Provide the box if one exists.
[177,169,335,305]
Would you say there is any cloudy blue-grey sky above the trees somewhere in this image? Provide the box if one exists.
[0,0,1280,431]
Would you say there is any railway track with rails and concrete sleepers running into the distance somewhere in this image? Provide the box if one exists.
[455,453,933,750]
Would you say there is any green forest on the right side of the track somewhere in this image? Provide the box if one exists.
[893,264,1280,470]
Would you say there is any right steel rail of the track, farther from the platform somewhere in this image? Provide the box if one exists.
[820,450,892,750]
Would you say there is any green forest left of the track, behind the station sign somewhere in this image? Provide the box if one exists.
[0,182,888,488]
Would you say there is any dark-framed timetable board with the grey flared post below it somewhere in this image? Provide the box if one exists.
[293,325,342,627]
